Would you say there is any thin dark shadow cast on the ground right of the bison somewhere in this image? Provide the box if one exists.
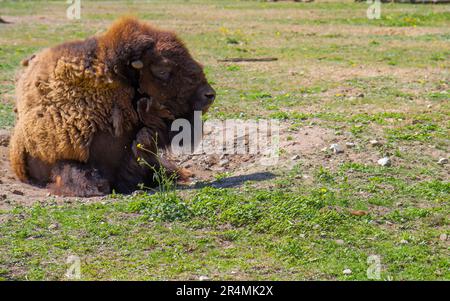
[178,172,276,189]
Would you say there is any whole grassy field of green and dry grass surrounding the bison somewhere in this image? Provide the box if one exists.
[0,0,450,280]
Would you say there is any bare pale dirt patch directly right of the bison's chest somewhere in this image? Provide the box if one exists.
[174,122,333,180]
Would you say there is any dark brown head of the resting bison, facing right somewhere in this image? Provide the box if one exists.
[99,18,216,118]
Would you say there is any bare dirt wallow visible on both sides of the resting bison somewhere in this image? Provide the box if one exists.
[0,123,333,209]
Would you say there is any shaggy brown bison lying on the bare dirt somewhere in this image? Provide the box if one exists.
[10,18,215,196]
